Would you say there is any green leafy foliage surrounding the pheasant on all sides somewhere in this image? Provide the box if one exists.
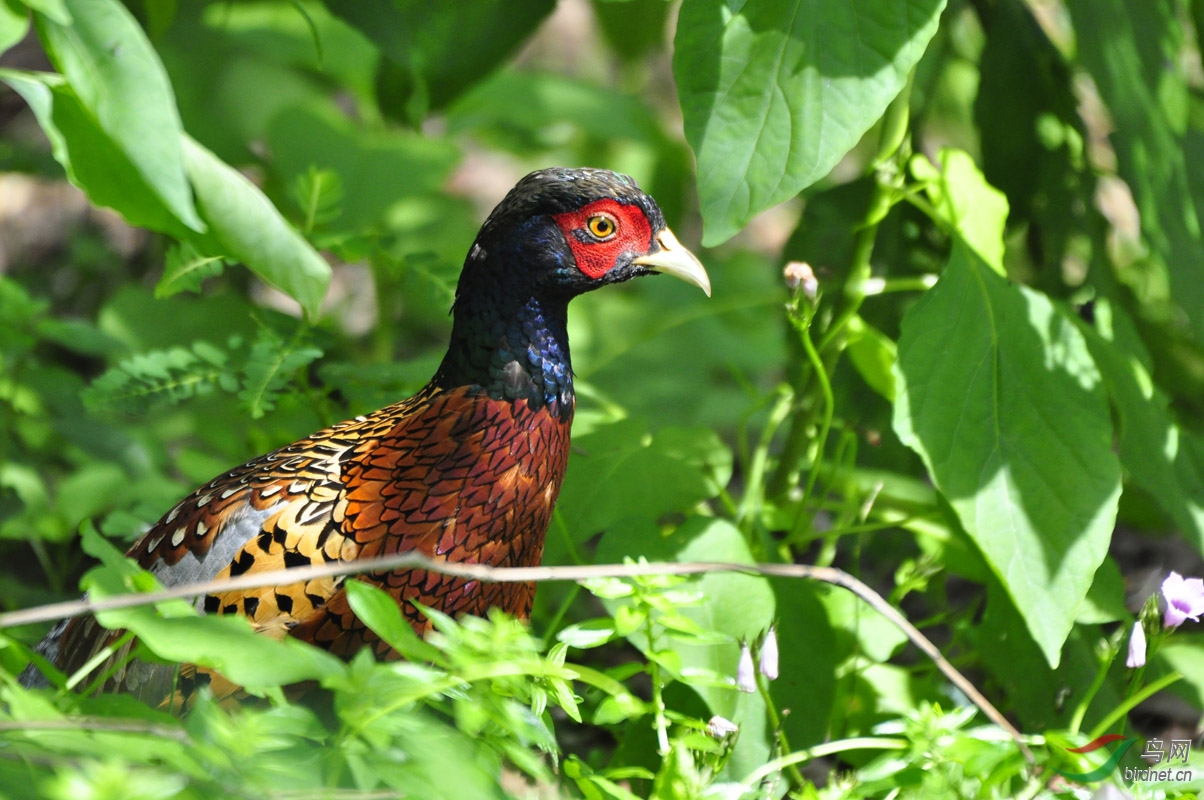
[0,0,1204,798]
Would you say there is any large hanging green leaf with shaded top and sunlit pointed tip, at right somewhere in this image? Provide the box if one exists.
[895,242,1121,666]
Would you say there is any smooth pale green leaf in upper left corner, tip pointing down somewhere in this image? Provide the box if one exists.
[35,0,205,231]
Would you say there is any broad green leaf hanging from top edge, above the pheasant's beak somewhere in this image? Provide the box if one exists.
[673,0,945,246]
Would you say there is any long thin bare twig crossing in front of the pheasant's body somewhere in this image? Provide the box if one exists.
[0,553,1033,763]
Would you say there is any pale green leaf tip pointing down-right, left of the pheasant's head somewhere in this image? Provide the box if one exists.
[184,136,330,317]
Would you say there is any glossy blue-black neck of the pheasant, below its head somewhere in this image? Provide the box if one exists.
[435,272,574,414]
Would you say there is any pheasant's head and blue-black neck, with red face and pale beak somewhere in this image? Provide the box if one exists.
[436,167,710,412]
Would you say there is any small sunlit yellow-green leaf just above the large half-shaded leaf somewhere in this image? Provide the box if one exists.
[909,147,1008,275]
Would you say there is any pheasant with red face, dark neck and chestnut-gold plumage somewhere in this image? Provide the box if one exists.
[22,169,710,702]
